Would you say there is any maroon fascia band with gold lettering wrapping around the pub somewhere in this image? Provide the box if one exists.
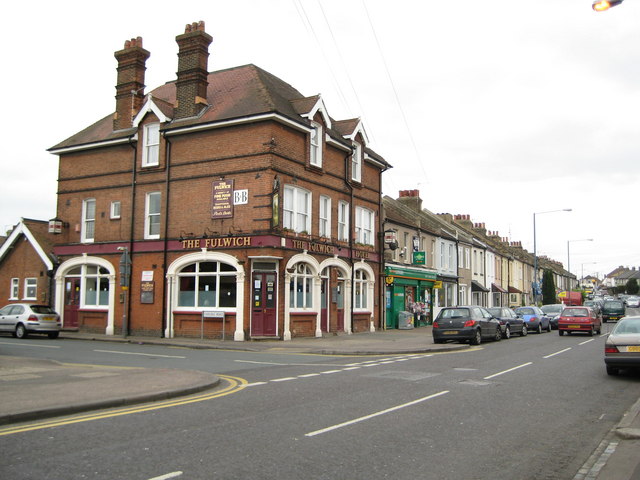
[53,235,380,262]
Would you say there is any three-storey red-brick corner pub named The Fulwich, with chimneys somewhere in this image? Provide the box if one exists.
[50,22,390,341]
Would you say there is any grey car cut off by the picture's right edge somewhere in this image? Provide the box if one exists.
[604,317,640,375]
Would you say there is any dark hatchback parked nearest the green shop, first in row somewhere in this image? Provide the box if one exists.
[432,305,502,345]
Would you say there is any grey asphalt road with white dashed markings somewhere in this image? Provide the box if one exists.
[0,318,640,480]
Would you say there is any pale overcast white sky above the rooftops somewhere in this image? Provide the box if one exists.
[0,0,640,277]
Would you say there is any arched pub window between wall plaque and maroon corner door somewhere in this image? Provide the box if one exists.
[178,262,236,308]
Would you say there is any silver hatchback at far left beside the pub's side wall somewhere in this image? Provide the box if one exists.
[0,303,62,338]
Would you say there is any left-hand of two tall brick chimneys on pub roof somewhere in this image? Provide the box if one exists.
[113,37,151,130]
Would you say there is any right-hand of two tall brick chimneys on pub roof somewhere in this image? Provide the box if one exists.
[175,21,213,119]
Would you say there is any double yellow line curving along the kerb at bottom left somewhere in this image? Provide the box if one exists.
[0,375,248,436]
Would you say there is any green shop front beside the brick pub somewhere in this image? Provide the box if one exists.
[385,265,437,329]
